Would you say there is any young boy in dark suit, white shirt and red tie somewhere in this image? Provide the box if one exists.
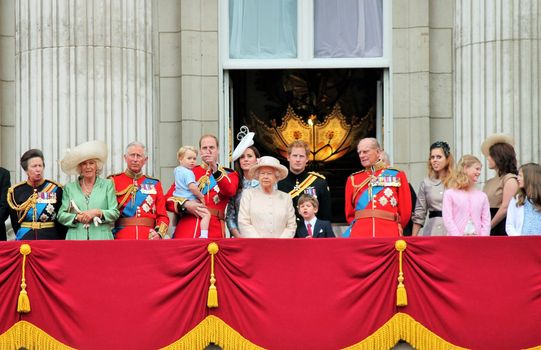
[295,194,336,238]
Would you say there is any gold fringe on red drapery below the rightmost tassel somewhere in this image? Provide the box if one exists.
[345,312,465,350]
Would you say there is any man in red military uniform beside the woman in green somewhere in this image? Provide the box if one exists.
[109,142,169,239]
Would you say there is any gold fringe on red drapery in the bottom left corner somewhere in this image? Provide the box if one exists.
[0,321,73,350]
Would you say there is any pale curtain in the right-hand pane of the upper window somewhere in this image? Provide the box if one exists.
[314,0,383,58]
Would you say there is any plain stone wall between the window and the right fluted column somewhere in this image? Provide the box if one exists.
[391,0,454,190]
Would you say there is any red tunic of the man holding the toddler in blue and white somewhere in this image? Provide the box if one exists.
[165,164,239,238]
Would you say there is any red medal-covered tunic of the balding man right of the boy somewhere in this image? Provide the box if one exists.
[345,163,411,237]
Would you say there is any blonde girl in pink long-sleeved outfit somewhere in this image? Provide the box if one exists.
[442,154,490,236]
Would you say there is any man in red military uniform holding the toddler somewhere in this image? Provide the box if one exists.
[166,135,239,238]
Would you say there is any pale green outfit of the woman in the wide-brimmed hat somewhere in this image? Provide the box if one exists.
[58,177,120,240]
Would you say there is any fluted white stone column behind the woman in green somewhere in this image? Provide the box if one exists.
[14,0,154,182]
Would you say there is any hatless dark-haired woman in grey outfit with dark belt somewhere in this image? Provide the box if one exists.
[411,141,455,236]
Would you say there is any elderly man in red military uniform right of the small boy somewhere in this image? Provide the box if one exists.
[344,138,411,237]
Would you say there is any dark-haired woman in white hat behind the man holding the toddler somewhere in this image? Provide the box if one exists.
[225,132,260,238]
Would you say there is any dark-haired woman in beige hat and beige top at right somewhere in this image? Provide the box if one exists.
[481,135,519,236]
